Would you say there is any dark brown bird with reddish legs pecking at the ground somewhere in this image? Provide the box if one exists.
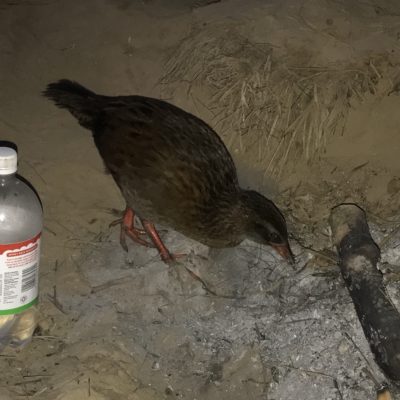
[43,80,294,262]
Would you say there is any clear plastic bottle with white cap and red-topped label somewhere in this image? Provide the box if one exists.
[0,147,43,351]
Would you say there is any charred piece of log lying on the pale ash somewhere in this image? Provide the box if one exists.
[329,204,400,381]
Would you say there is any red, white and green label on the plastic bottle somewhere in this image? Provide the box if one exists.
[0,233,41,315]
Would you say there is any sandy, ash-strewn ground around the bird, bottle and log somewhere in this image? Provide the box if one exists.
[0,0,400,400]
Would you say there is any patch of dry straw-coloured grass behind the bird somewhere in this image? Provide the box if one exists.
[161,27,380,176]
